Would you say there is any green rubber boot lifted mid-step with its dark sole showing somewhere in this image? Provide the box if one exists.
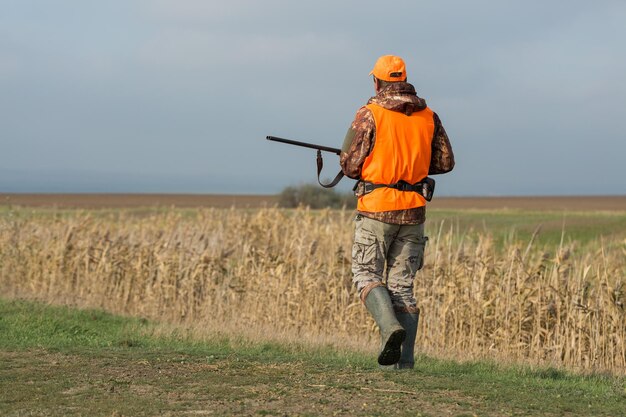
[365,287,404,365]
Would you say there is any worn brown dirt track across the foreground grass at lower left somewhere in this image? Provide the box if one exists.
[0,351,489,416]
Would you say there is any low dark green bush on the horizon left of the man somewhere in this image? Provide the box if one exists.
[278,184,356,209]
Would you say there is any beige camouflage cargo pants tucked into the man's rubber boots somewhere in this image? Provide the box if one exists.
[352,214,428,313]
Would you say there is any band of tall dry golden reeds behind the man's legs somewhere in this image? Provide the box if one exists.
[0,208,626,373]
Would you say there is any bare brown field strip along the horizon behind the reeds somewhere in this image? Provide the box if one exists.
[0,193,626,211]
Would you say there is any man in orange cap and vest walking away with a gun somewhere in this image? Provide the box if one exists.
[340,55,454,368]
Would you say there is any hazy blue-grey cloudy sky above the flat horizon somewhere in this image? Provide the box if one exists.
[0,0,626,196]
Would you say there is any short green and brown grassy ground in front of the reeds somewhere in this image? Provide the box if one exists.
[0,300,626,416]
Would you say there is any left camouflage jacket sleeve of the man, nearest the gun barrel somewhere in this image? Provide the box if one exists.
[339,107,376,179]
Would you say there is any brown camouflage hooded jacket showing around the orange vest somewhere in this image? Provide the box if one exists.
[339,82,454,224]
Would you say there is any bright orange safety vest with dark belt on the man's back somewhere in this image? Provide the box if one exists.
[357,104,435,213]
